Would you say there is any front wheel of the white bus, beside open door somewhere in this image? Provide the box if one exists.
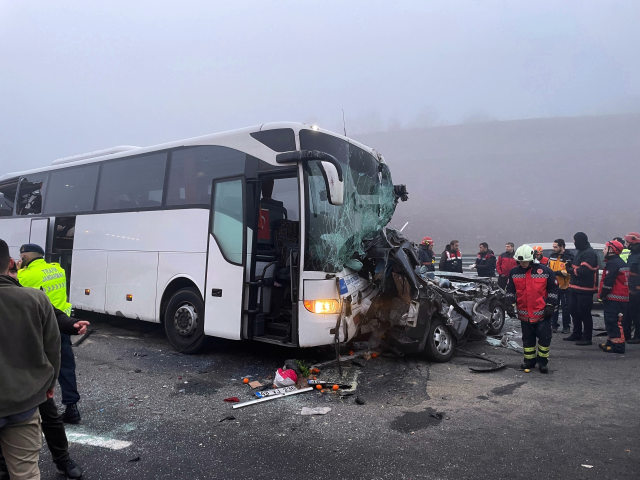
[164,287,206,355]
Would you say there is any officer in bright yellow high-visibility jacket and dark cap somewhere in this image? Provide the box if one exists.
[18,243,81,424]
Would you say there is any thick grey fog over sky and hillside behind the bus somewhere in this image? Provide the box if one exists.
[0,0,640,252]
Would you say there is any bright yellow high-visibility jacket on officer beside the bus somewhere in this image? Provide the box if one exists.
[18,258,72,315]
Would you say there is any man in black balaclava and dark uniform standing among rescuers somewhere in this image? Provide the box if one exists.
[562,232,599,346]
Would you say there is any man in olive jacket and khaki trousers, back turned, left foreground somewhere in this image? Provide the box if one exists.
[0,240,60,479]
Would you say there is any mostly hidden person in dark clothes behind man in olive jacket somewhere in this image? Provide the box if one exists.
[0,256,89,480]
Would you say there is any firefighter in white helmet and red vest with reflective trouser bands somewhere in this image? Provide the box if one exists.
[506,245,558,373]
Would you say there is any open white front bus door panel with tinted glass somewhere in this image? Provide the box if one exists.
[204,176,250,340]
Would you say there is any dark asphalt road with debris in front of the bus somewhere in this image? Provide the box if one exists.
[40,317,640,480]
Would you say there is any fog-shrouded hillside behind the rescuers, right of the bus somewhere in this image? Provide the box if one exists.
[358,115,640,253]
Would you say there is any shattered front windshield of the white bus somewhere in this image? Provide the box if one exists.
[300,130,396,272]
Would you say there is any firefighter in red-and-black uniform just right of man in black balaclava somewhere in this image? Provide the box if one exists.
[598,240,629,353]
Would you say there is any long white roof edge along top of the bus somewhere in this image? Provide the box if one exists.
[0,122,384,181]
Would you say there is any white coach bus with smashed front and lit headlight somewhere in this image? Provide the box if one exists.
[0,123,397,353]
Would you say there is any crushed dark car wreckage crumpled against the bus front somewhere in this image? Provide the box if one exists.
[324,185,505,362]
